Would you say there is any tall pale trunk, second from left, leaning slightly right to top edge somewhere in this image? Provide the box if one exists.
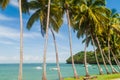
[42,0,51,80]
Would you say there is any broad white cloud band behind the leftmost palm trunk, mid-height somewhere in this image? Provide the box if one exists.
[0,26,40,44]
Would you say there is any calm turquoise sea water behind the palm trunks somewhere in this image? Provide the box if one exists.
[0,63,117,80]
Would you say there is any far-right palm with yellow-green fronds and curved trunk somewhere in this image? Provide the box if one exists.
[101,10,119,73]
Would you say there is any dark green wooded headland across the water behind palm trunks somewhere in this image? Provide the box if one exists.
[66,51,120,64]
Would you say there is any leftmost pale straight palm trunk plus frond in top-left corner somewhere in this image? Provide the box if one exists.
[0,0,26,80]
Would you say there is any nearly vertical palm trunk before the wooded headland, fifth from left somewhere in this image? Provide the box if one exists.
[84,34,90,77]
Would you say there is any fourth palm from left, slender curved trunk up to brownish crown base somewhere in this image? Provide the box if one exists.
[63,0,79,79]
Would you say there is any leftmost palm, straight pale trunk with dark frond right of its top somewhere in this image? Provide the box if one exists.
[18,0,29,80]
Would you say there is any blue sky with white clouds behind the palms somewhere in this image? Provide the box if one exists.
[0,0,120,63]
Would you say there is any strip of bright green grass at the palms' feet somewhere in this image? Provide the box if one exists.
[64,74,120,80]
